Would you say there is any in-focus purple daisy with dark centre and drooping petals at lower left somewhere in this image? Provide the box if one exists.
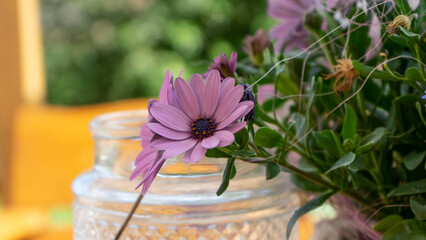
[130,70,254,194]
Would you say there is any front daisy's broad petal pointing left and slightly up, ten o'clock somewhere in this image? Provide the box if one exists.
[150,102,191,131]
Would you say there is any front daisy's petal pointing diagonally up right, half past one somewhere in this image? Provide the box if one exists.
[214,85,244,122]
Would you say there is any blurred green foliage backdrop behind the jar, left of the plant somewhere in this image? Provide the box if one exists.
[42,0,273,105]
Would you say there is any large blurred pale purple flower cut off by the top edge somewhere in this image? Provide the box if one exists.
[268,0,319,52]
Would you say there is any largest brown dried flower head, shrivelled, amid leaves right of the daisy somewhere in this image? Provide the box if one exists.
[325,58,359,92]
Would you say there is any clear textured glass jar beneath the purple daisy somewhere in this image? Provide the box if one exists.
[72,110,299,240]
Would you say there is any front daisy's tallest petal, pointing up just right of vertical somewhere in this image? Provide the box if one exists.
[203,70,220,117]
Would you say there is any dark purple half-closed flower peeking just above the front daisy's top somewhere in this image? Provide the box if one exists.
[203,52,237,80]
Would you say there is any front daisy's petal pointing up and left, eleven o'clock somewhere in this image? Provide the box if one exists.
[175,78,200,120]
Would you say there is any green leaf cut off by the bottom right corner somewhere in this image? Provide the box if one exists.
[381,219,426,240]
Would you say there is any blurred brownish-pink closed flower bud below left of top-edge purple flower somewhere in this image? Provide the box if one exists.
[243,29,271,65]
